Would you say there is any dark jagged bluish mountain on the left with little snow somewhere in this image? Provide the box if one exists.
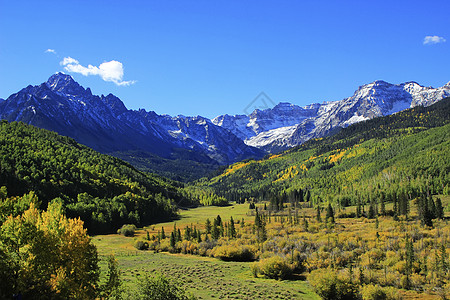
[0,73,262,180]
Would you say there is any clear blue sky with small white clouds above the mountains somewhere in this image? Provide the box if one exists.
[0,0,450,118]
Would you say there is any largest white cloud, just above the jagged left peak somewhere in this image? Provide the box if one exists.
[60,57,136,86]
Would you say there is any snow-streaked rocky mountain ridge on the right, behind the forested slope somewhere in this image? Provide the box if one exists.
[213,80,450,153]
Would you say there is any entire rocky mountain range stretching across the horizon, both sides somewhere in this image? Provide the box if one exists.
[0,73,450,180]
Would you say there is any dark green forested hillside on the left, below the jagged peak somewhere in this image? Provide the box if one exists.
[0,121,202,233]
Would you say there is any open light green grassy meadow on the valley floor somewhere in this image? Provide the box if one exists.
[93,204,319,299]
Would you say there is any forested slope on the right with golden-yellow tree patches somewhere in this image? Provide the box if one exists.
[199,98,450,203]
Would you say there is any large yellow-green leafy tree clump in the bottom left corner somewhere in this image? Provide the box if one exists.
[0,202,99,299]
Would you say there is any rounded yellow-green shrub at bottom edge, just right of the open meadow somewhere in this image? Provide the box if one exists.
[308,269,359,300]
